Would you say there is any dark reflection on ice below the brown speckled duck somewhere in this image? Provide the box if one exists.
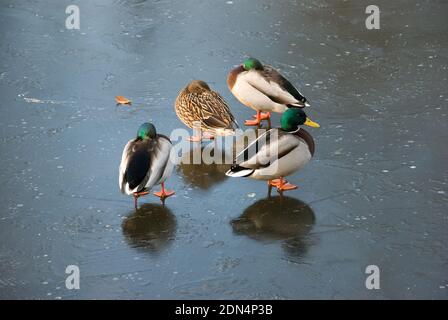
[177,145,230,190]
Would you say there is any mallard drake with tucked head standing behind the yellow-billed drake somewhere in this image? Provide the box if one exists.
[227,58,309,126]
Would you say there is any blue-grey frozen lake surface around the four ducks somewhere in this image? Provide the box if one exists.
[0,0,448,299]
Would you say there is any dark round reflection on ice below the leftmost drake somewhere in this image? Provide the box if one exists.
[122,203,177,252]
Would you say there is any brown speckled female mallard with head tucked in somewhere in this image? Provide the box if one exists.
[175,80,237,142]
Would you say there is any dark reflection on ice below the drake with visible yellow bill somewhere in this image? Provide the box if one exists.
[231,196,315,257]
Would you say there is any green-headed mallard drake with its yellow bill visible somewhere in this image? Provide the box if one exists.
[226,108,320,193]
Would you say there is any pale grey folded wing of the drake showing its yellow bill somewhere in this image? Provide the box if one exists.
[235,129,300,169]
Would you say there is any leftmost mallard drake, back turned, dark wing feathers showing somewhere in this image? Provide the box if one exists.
[119,123,174,210]
